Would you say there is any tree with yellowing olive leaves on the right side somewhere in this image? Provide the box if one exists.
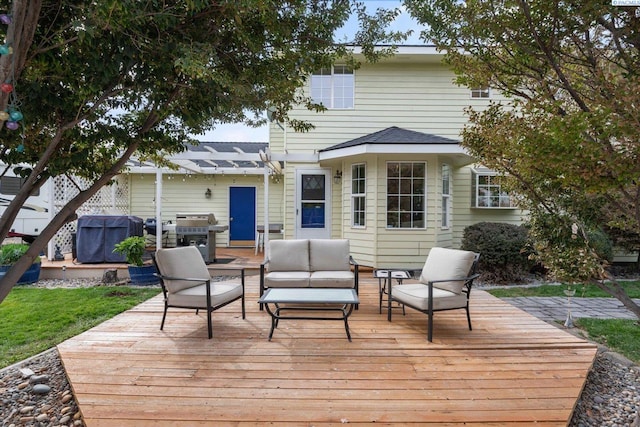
[405,0,640,317]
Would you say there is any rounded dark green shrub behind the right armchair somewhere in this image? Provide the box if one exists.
[462,222,533,283]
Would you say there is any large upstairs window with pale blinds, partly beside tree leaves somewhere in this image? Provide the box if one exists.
[311,65,355,109]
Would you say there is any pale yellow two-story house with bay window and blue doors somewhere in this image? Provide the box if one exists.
[130,46,522,267]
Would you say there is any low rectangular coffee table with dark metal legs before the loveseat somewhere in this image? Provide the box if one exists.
[258,288,360,341]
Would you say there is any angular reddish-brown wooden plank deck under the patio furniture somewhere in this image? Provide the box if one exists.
[58,273,596,427]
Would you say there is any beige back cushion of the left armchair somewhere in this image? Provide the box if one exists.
[156,246,211,293]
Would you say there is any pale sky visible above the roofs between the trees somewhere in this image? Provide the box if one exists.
[193,0,422,142]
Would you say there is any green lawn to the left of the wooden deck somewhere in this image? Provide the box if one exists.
[0,286,160,368]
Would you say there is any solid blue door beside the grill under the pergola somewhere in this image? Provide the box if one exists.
[229,187,256,246]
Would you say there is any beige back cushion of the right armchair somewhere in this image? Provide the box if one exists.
[420,248,475,294]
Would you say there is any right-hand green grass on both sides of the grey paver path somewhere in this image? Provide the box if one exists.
[488,281,640,363]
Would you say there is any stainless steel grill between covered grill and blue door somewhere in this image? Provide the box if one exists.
[176,213,229,263]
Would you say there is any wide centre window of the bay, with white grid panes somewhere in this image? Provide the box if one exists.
[387,162,427,228]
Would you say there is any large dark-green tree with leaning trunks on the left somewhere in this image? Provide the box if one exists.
[0,0,408,302]
